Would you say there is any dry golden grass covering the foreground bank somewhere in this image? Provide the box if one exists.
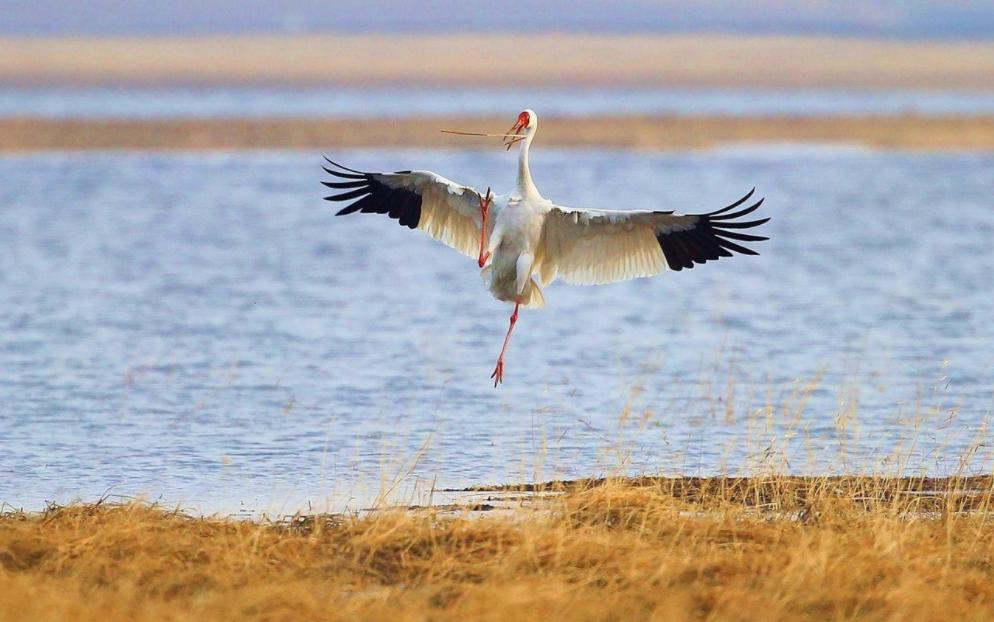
[0,476,994,621]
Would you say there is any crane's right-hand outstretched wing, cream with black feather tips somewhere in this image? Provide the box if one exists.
[536,188,769,285]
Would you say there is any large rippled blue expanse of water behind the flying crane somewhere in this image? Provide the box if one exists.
[0,145,994,512]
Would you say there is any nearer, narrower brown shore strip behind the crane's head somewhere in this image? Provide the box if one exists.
[0,116,994,153]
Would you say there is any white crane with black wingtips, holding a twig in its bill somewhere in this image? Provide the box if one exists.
[321,109,769,388]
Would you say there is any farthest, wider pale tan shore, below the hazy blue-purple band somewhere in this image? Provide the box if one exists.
[0,33,994,89]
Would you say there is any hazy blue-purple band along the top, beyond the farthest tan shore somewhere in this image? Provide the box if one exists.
[3,0,994,39]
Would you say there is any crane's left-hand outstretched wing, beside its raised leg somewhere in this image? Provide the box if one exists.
[321,158,492,257]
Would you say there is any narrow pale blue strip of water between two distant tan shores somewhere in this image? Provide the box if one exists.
[0,87,994,118]
